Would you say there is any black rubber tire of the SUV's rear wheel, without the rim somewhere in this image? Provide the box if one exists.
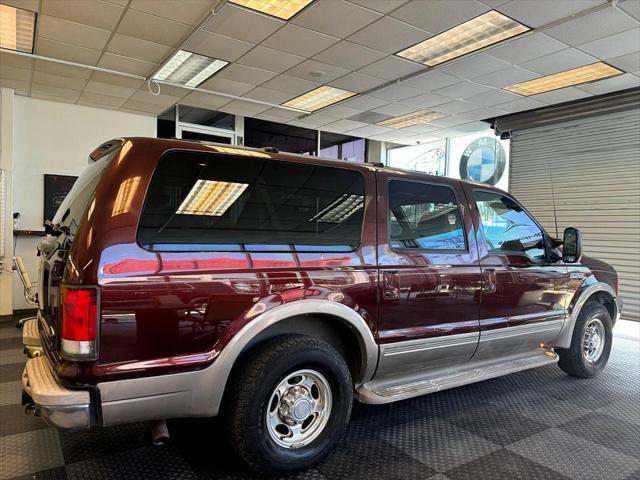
[223,335,353,474]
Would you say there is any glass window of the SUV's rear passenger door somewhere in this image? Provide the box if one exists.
[389,180,466,250]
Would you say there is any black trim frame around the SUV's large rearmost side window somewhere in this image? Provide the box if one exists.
[135,148,367,255]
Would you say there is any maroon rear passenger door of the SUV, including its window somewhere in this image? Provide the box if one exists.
[377,172,482,378]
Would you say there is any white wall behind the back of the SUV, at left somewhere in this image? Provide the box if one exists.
[13,96,156,310]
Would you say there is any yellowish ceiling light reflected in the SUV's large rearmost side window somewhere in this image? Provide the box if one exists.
[176,180,249,217]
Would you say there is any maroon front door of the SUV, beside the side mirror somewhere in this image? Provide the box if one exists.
[465,185,568,360]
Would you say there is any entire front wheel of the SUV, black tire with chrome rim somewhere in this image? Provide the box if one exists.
[556,302,613,378]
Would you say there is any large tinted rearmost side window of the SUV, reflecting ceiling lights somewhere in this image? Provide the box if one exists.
[138,152,364,252]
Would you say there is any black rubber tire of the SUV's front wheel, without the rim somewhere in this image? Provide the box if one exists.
[556,302,613,378]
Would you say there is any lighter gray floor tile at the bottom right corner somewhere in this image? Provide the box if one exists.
[507,428,640,480]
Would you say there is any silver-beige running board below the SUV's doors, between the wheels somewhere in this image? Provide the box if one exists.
[356,350,558,404]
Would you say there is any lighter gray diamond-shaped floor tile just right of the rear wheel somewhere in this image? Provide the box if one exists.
[376,419,500,472]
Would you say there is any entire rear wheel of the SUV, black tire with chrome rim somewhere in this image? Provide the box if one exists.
[225,335,353,474]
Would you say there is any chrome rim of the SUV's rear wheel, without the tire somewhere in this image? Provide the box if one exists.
[266,370,331,449]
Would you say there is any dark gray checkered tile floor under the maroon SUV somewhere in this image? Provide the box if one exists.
[0,316,640,480]
